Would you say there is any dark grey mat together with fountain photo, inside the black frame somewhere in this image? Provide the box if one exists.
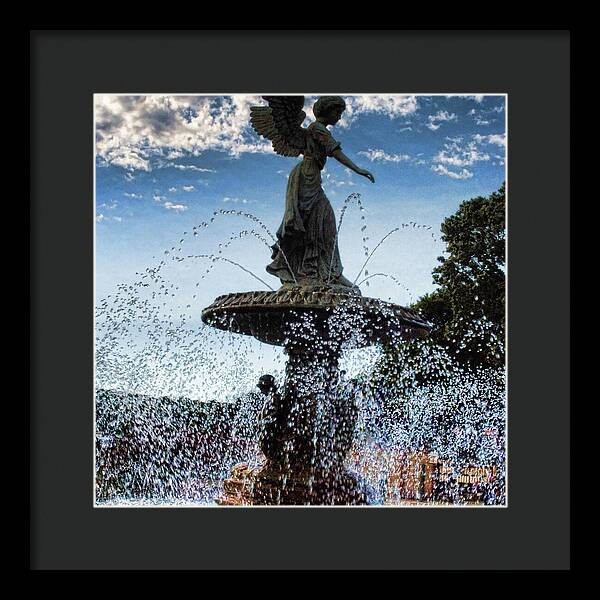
[31,31,570,569]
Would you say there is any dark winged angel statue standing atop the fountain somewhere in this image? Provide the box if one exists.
[250,96,375,291]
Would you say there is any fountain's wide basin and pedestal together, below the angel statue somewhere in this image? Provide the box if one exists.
[202,285,430,506]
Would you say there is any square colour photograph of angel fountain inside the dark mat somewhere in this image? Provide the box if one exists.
[94,89,510,510]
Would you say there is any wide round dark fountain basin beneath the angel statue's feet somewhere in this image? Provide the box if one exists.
[202,285,431,349]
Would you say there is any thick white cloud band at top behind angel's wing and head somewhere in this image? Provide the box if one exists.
[95,94,418,170]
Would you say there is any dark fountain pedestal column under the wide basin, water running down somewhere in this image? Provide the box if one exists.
[252,334,366,505]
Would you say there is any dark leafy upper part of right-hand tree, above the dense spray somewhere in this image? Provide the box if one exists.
[413,184,506,366]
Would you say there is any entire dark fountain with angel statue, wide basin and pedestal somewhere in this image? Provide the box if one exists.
[202,96,430,505]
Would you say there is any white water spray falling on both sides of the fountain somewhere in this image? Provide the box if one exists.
[95,199,506,506]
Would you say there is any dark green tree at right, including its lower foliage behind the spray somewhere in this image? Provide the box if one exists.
[370,185,505,431]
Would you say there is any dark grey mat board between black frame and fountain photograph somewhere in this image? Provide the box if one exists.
[30,31,570,569]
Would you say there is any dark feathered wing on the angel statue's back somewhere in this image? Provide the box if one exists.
[250,96,306,156]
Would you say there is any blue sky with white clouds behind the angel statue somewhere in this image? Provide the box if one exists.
[95,95,506,321]
